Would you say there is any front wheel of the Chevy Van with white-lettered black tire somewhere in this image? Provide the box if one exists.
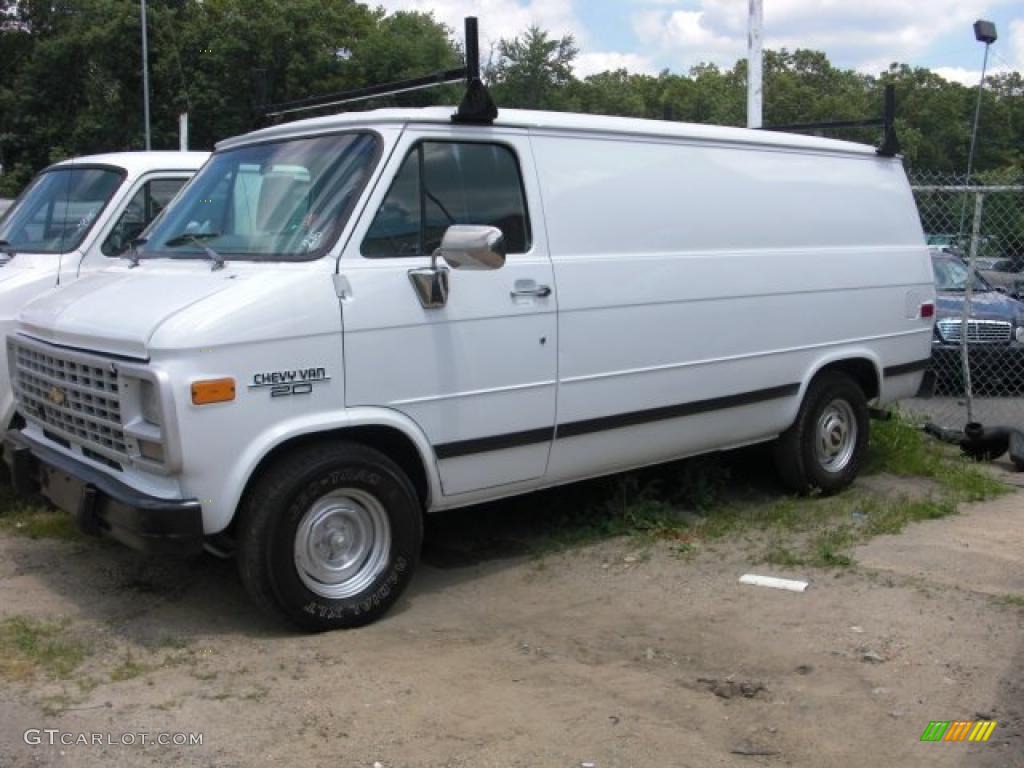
[237,443,423,632]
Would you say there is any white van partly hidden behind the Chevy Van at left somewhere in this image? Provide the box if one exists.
[0,152,210,428]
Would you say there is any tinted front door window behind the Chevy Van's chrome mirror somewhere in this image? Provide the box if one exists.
[360,141,530,258]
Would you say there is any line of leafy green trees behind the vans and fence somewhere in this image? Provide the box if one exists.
[0,10,1024,195]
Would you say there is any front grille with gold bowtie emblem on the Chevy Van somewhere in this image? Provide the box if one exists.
[10,340,129,463]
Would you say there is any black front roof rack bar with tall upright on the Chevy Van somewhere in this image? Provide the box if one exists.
[257,16,498,125]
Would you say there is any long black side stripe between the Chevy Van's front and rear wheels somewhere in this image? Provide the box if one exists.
[434,383,800,459]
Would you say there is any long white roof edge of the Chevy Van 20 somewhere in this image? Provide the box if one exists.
[216,106,877,157]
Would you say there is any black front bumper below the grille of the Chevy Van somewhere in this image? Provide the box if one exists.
[3,430,204,555]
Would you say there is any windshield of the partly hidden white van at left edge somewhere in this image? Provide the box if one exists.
[0,166,125,253]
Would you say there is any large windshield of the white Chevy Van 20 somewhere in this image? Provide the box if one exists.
[138,133,379,260]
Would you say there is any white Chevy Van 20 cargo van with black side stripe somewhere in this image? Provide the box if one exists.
[6,109,935,630]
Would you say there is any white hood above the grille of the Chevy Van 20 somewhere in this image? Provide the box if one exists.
[16,265,243,359]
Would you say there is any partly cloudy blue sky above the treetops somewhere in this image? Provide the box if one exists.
[371,0,1024,85]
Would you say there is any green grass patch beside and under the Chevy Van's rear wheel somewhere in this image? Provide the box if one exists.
[520,415,1010,568]
